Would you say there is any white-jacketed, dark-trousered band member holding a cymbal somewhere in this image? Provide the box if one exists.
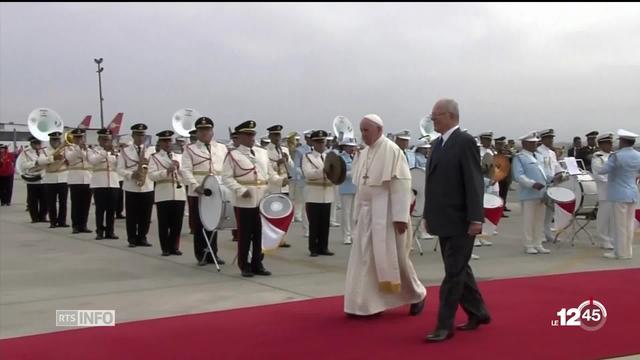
[302,130,335,257]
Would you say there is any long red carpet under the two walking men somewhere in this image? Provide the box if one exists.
[0,269,640,360]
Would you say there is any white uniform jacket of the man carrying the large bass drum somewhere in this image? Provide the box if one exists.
[180,140,227,197]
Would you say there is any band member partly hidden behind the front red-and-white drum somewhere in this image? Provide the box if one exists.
[266,125,293,248]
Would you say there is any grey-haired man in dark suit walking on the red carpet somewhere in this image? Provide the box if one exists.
[424,99,491,342]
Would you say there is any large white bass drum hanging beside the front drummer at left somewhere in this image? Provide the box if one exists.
[198,175,236,231]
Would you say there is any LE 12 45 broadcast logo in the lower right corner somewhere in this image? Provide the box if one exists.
[551,299,607,331]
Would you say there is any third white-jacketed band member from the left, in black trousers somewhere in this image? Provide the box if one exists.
[64,128,92,234]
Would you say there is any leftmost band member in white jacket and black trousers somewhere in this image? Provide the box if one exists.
[16,136,48,223]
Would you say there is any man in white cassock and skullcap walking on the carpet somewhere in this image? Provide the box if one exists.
[344,114,427,315]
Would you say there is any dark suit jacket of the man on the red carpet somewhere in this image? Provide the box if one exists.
[423,129,484,237]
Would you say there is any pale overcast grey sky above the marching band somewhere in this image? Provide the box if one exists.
[0,3,640,140]
